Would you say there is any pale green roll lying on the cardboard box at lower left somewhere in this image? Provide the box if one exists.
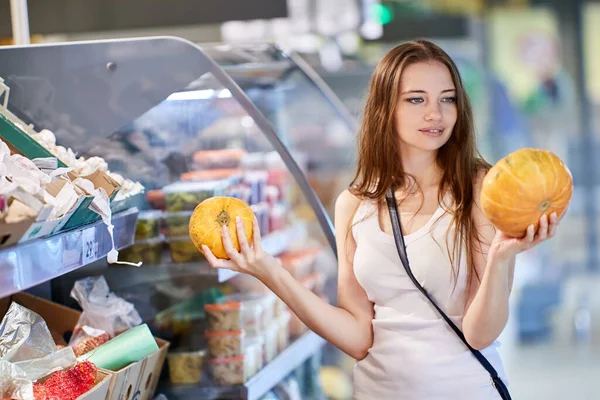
[78,324,158,371]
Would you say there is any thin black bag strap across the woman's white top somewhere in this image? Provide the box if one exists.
[385,187,511,400]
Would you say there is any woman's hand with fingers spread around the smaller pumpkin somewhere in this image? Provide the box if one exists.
[202,217,279,279]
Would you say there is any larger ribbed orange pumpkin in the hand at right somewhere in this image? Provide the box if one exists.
[481,149,573,237]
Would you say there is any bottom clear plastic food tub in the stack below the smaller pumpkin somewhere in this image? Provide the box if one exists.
[208,352,256,386]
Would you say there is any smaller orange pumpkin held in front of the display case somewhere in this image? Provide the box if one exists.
[189,197,254,259]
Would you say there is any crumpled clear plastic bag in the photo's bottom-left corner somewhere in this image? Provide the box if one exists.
[0,302,75,399]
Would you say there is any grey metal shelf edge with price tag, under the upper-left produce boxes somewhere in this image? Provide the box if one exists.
[0,208,138,298]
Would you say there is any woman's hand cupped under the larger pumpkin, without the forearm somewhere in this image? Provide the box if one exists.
[489,213,564,260]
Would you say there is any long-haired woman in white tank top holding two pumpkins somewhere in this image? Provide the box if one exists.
[204,41,558,400]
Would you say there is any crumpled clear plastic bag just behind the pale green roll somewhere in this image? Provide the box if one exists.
[69,276,142,346]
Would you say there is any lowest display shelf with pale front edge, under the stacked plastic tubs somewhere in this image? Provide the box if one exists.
[157,331,325,400]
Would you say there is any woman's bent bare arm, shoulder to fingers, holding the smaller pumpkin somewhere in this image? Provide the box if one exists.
[203,191,373,360]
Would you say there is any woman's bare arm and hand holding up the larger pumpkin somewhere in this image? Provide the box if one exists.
[462,174,558,350]
